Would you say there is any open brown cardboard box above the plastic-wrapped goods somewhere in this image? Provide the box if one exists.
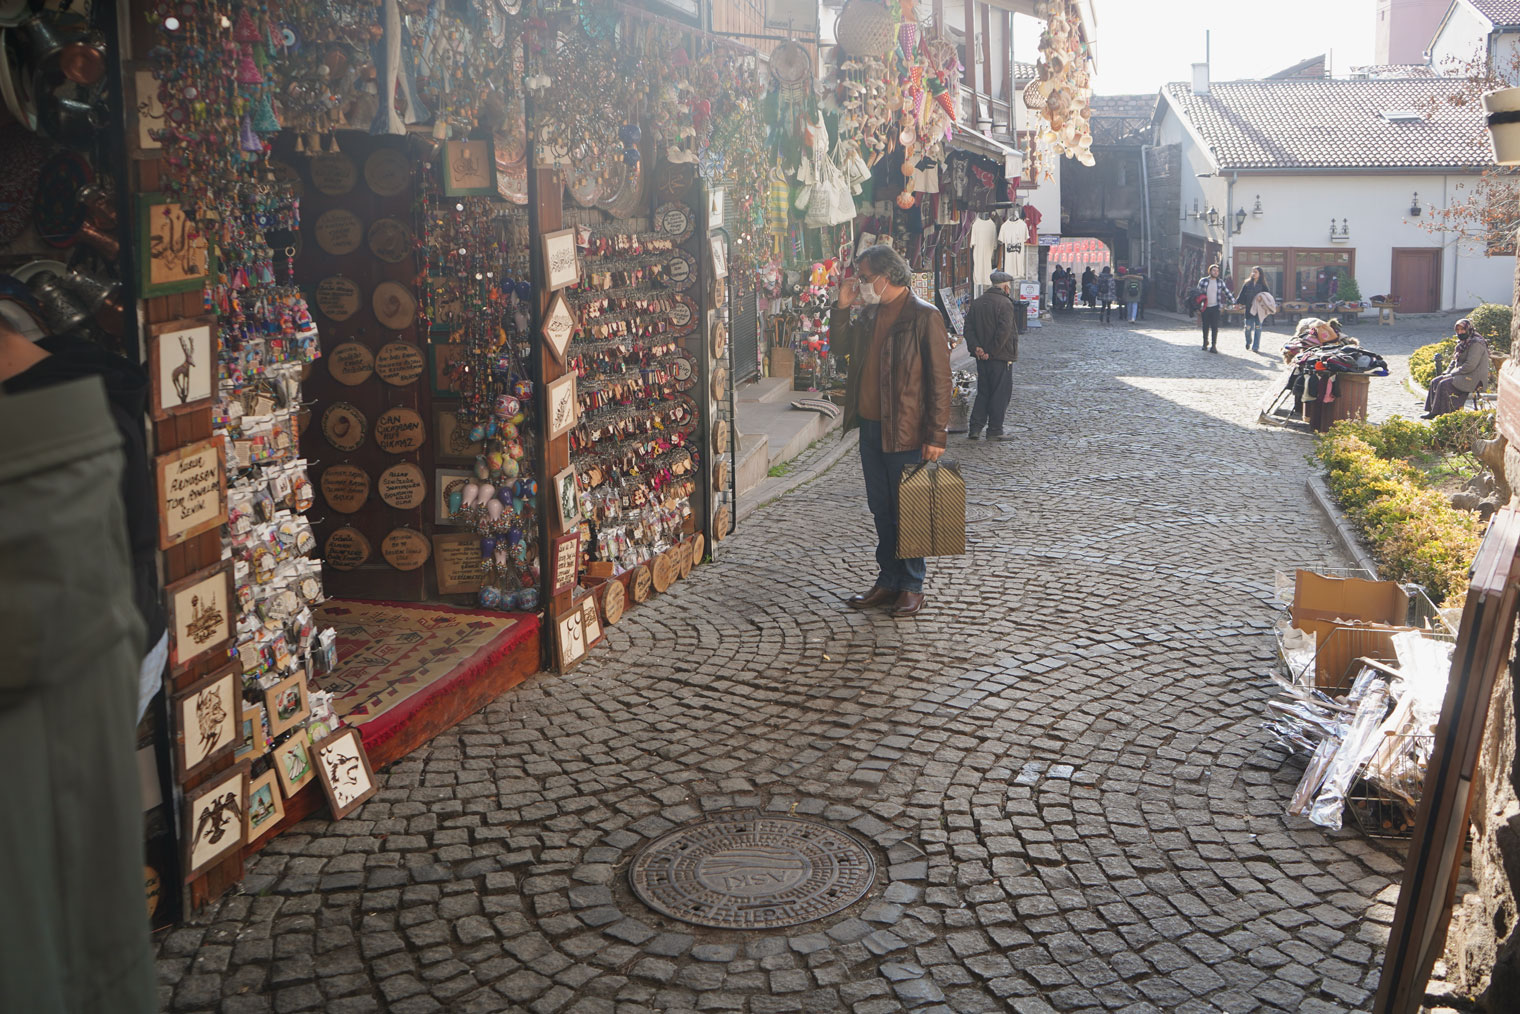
[1292,570,1412,690]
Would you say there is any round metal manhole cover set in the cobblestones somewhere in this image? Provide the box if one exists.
[628,816,876,929]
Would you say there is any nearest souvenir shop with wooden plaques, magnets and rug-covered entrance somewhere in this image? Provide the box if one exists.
[0,0,766,923]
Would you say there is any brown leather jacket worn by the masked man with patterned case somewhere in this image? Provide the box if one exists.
[828,292,950,453]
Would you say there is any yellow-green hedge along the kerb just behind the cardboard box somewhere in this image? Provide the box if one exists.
[1315,425,1485,602]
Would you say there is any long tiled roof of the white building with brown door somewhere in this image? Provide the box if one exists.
[1161,78,1493,169]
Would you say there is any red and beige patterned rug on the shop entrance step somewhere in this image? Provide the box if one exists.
[315,599,538,743]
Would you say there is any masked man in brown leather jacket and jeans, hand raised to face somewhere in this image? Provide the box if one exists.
[828,246,950,616]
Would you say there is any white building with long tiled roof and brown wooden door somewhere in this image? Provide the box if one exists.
[1155,65,1520,313]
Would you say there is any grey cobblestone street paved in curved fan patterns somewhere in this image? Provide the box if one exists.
[158,315,1453,1014]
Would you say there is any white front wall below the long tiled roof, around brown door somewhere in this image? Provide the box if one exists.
[1216,175,1515,310]
